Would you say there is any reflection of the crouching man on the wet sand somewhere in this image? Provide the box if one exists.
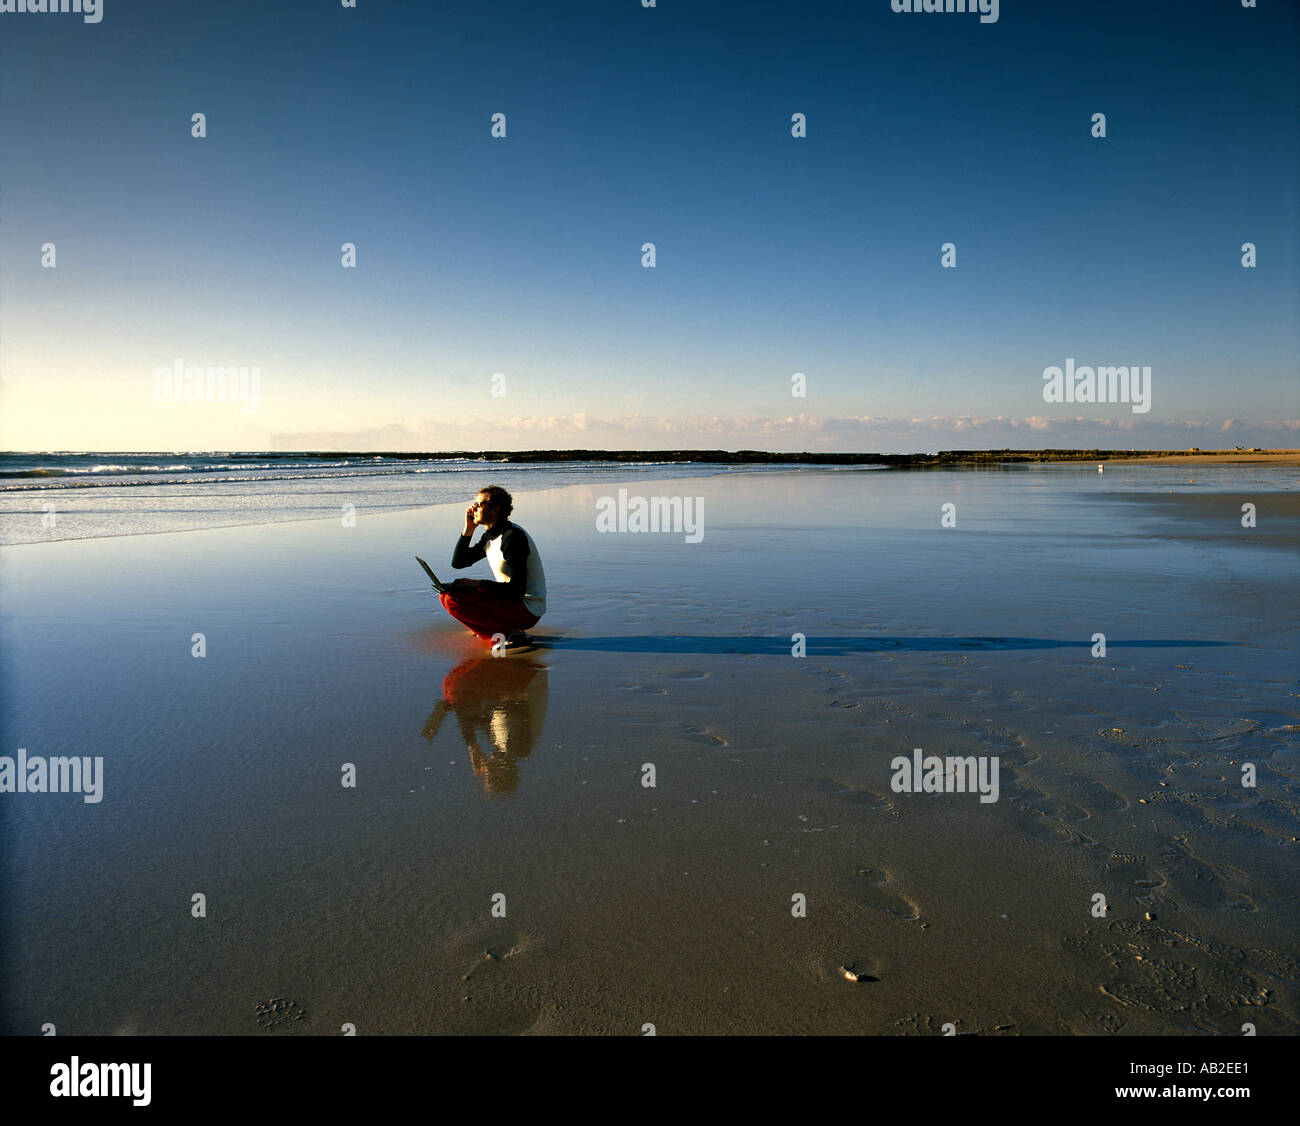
[420,653,549,793]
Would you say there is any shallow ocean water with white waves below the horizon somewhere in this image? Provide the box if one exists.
[0,452,1300,545]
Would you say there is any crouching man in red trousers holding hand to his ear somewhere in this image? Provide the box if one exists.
[439,485,546,649]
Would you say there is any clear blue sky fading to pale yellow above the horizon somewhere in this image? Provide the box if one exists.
[0,0,1300,451]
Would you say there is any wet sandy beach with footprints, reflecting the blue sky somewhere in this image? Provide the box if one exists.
[0,463,1300,1036]
